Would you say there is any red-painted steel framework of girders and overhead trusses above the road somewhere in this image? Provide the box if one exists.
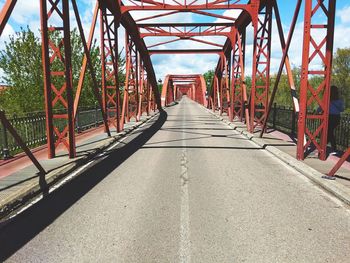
[0,0,335,167]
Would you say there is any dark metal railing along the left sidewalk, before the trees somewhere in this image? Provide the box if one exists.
[0,107,103,159]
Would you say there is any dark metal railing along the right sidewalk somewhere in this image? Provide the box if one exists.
[268,104,350,150]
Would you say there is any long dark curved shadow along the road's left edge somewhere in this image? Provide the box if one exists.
[0,111,167,262]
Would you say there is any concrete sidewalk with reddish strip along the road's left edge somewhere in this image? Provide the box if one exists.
[0,113,158,221]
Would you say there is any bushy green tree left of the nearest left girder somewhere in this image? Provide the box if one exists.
[0,28,44,113]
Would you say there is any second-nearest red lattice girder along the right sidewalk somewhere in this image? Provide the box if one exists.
[249,1,272,132]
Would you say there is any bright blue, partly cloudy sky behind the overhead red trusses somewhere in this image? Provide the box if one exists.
[0,0,350,78]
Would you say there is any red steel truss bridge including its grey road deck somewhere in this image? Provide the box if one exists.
[0,0,350,262]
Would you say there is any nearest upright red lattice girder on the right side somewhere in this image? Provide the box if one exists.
[297,0,336,160]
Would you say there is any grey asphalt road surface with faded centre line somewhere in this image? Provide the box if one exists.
[0,98,350,263]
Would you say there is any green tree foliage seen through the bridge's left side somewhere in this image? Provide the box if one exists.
[0,27,125,114]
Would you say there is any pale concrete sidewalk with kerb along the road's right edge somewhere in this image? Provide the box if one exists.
[207,109,350,205]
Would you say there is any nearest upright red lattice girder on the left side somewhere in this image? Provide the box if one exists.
[40,0,76,158]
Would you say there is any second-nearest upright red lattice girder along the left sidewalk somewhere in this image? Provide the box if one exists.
[100,6,123,132]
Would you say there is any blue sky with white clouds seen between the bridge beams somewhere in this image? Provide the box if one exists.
[0,0,350,82]
